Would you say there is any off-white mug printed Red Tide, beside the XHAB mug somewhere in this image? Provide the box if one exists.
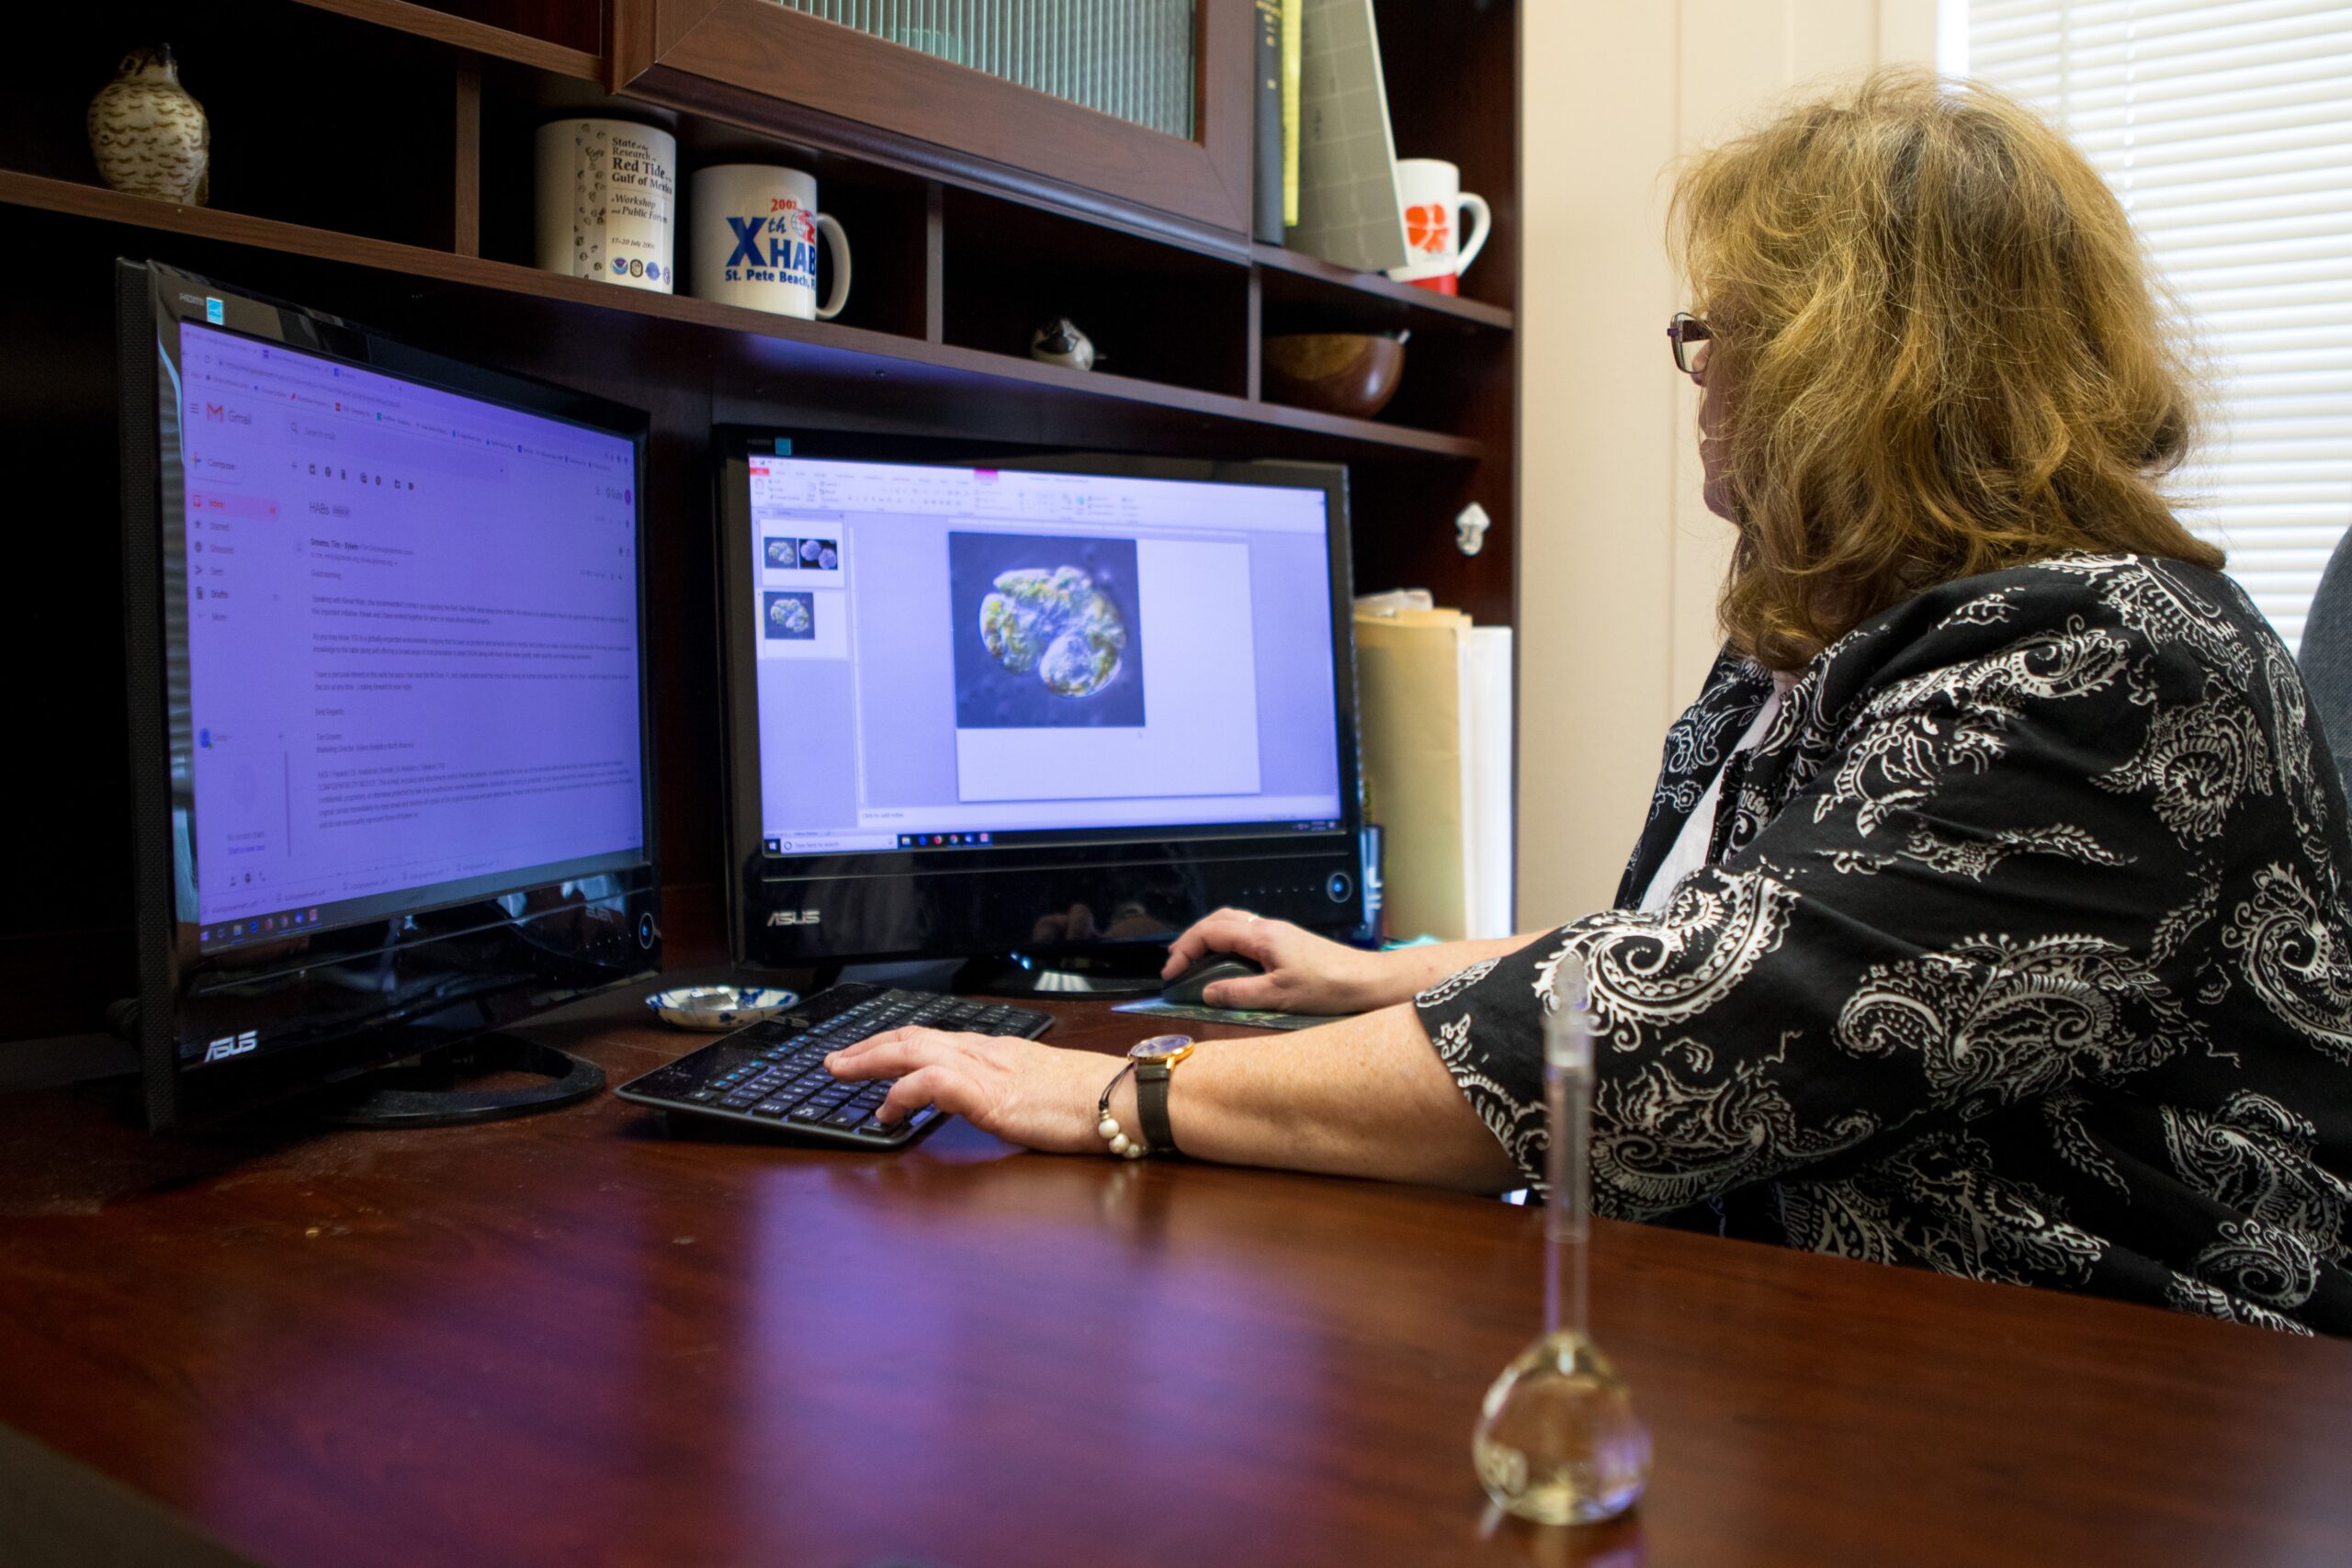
[538,120,677,294]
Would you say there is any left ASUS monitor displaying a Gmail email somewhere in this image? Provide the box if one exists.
[118,261,661,1126]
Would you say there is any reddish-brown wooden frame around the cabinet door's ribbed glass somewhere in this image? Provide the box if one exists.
[612,0,1253,240]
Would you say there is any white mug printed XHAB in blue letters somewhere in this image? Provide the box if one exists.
[694,163,849,322]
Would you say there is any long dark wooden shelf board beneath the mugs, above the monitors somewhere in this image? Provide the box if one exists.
[0,172,1487,461]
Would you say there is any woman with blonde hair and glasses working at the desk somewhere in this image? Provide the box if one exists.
[835,73,2352,1333]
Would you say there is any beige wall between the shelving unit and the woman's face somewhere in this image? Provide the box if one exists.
[1520,0,1936,929]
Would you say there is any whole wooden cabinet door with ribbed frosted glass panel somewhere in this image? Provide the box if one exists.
[609,0,1259,232]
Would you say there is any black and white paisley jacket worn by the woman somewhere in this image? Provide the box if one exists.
[1419,558,2352,1333]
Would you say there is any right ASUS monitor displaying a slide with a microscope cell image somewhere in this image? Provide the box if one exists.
[719,428,1364,987]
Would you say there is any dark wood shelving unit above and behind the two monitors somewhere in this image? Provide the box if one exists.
[0,0,1520,1030]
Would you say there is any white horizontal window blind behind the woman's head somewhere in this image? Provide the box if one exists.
[1943,0,2352,647]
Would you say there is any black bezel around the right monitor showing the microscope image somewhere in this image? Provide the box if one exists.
[713,425,1364,968]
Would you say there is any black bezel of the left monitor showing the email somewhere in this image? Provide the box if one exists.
[115,259,661,1128]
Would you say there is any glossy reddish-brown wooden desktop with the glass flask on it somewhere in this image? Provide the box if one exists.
[0,1004,2352,1568]
